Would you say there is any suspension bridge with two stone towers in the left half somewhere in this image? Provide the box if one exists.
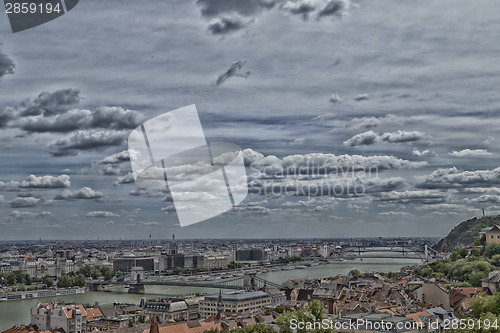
[88,267,281,294]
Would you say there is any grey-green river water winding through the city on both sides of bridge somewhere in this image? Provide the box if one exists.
[0,254,422,332]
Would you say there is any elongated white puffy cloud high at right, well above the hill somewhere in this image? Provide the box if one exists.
[344,130,427,147]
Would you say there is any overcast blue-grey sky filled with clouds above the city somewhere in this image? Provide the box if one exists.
[0,0,500,240]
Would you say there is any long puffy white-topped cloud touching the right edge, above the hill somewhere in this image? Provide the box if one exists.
[416,167,500,189]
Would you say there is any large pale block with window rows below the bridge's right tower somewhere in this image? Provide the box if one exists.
[199,291,272,318]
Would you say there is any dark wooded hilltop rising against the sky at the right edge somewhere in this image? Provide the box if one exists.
[434,216,500,252]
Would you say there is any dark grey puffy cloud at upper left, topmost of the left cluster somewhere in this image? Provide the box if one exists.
[21,88,80,116]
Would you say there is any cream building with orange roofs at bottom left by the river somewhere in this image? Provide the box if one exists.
[30,303,87,333]
